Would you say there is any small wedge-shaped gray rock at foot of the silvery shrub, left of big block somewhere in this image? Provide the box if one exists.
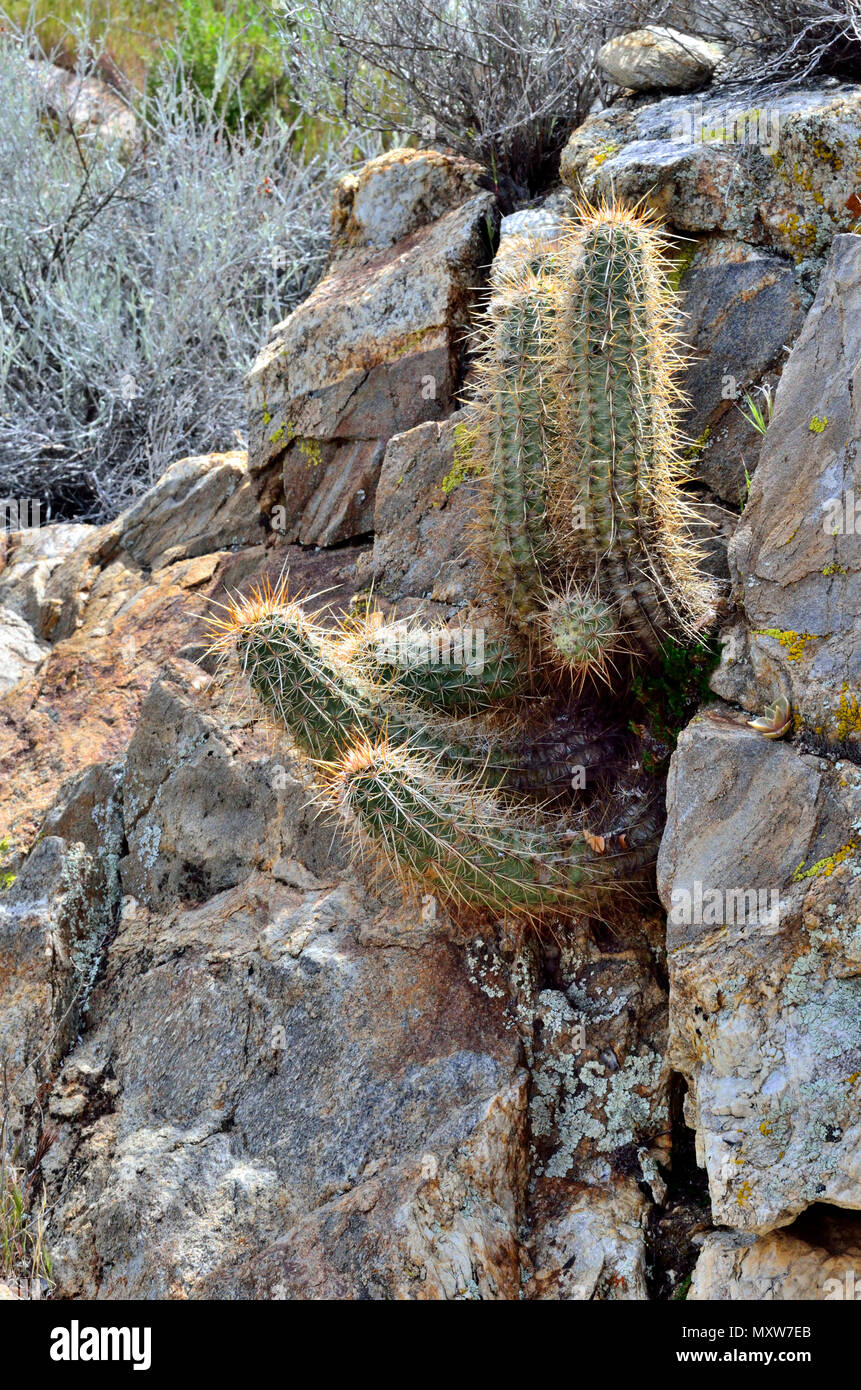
[120,449,266,570]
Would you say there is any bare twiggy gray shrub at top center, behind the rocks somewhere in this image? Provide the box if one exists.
[280,0,612,200]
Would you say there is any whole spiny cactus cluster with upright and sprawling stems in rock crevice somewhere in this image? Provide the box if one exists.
[214,198,712,922]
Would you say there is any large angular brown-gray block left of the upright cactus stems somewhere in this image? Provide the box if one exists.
[248,150,498,545]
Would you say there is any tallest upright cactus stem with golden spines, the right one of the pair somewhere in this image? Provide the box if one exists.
[548,197,714,667]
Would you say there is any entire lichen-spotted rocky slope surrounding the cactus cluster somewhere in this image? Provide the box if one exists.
[0,54,861,1300]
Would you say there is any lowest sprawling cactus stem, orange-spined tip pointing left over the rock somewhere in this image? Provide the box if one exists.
[324,739,650,920]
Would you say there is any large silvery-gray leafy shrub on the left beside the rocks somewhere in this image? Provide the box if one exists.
[0,12,374,518]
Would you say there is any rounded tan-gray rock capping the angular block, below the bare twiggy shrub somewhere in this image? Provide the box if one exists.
[332,150,487,257]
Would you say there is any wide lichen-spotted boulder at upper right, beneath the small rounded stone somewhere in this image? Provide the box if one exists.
[561,83,861,265]
